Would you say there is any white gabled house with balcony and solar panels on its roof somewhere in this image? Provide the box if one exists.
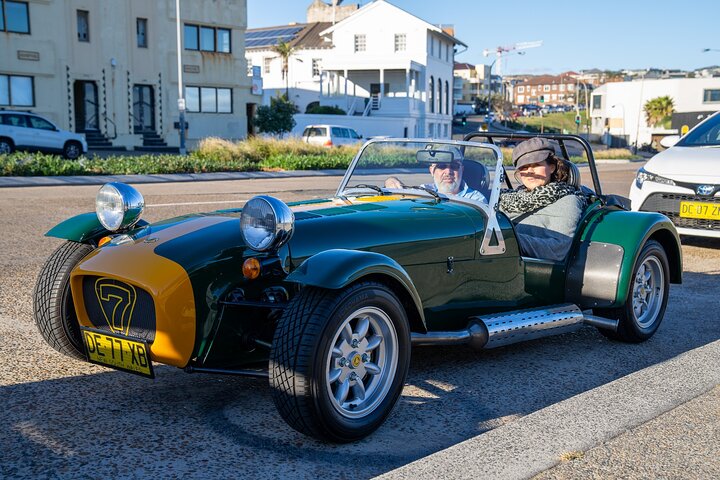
[246,0,465,138]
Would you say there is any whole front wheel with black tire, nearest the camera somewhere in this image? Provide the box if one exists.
[269,282,410,442]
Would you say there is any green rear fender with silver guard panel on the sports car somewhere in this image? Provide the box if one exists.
[566,209,682,308]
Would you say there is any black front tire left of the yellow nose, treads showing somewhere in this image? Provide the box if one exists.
[33,242,94,360]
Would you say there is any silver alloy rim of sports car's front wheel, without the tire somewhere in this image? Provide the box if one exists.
[325,307,398,418]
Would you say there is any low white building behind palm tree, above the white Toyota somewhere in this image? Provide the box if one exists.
[590,77,720,147]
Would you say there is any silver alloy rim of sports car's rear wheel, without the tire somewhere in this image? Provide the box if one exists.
[632,255,665,328]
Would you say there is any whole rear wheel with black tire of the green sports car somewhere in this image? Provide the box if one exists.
[595,240,670,343]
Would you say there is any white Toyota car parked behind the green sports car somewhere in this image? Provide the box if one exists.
[630,112,720,238]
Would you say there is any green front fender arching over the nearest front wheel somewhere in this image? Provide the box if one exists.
[286,249,427,331]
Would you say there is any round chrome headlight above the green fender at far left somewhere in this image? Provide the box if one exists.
[95,182,145,232]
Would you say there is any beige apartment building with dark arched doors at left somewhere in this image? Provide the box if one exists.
[0,0,256,149]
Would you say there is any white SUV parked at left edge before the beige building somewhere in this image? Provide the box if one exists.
[0,110,87,160]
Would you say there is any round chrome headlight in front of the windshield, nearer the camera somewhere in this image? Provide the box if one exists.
[240,195,295,252]
